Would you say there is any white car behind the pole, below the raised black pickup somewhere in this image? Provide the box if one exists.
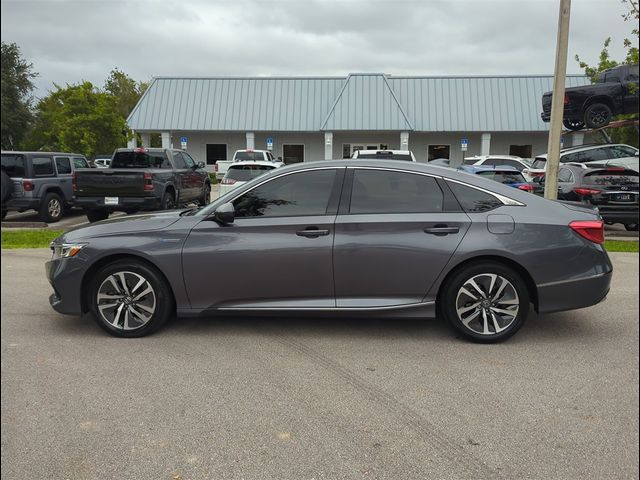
[522,143,638,179]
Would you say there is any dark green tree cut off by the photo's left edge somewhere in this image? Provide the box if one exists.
[0,42,38,150]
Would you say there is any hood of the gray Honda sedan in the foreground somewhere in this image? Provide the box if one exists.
[64,210,184,241]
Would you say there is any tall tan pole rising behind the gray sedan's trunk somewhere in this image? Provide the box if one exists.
[544,0,571,200]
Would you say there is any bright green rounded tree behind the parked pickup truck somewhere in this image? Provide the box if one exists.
[28,82,129,158]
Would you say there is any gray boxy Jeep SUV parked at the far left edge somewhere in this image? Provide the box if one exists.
[2,151,89,223]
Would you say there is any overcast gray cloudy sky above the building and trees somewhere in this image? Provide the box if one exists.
[0,0,632,96]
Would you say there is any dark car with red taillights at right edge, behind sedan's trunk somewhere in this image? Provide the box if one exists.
[538,164,638,231]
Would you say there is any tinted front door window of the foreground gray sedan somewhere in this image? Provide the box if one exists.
[233,170,336,218]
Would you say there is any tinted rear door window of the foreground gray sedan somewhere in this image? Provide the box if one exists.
[349,170,443,213]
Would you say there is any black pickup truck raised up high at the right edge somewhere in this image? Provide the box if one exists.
[541,65,638,130]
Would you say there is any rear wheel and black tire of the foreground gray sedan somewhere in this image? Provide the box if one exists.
[439,261,529,343]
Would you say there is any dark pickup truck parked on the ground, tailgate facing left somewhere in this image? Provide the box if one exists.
[73,148,211,222]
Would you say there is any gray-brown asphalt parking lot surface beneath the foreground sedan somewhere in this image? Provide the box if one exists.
[1,249,638,480]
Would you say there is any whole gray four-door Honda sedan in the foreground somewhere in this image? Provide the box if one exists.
[46,159,612,342]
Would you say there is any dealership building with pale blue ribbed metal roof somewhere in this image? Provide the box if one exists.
[127,73,589,168]
